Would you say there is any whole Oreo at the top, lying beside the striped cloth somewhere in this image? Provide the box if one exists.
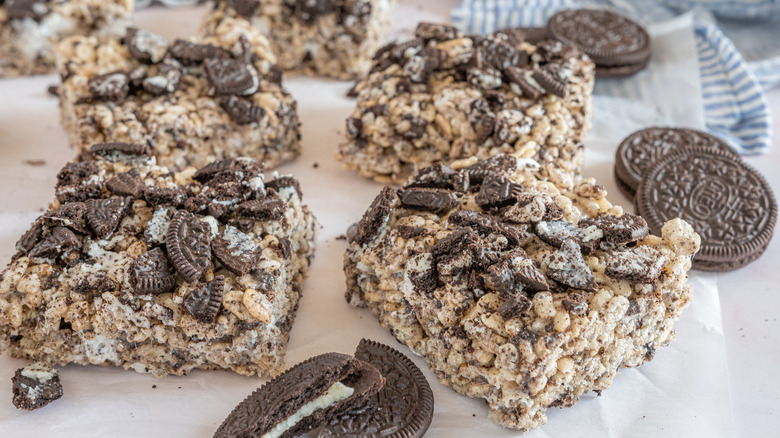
[547,9,651,78]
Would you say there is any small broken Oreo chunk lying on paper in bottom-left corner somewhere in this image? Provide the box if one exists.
[11,362,62,411]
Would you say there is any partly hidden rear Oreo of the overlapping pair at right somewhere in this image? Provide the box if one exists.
[615,127,740,199]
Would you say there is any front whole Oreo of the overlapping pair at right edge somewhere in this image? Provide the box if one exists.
[636,146,777,271]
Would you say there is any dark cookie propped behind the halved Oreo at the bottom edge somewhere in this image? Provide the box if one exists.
[319,339,433,438]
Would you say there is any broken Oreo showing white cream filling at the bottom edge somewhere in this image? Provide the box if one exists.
[214,353,384,438]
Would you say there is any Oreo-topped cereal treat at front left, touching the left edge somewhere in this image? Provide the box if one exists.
[0,143,316,376]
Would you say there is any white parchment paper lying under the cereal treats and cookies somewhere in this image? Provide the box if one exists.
[0,1,733,438]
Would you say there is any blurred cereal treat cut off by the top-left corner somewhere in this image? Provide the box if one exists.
[0,0,133,78]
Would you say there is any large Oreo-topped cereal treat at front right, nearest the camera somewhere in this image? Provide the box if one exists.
[344,155,700,430]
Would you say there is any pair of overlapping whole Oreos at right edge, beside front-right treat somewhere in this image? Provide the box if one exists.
[615,127,777,272]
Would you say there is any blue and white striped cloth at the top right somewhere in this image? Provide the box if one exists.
[452,0,780,155]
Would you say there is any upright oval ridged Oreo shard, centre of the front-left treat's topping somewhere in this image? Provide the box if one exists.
[165,210,211,283]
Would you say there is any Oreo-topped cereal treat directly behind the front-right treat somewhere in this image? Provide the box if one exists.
[337,23,594,184]
